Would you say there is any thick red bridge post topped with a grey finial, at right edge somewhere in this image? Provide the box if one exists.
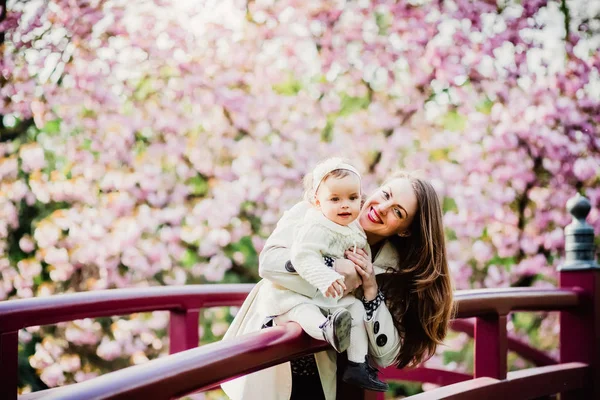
[558,194,600,400]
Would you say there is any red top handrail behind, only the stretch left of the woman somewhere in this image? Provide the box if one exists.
[0,284,254,333]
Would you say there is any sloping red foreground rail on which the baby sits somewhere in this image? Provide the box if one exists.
[25,323,328,400]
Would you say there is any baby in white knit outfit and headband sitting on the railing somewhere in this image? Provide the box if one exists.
[262,158,388,391]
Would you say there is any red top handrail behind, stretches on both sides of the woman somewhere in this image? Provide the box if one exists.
[0,284,580,332]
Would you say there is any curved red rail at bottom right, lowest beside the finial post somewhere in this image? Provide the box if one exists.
[410,362,590,400]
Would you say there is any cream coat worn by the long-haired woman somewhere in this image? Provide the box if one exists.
[221,202,400,400]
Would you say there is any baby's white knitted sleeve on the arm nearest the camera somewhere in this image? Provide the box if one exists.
[292,224,344,295]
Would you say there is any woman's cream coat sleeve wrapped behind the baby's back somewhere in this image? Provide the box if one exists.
[258,202,318,298]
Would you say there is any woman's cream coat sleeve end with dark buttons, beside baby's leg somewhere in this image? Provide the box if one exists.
[365,302,401,368]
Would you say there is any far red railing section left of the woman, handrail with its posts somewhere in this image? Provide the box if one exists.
[0,285,253,400]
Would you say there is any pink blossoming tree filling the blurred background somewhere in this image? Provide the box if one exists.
[0,0,600,389]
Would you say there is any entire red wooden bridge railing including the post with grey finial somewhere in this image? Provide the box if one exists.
[0,198,600,400]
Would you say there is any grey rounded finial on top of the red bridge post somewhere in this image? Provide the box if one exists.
[558,193,600,271]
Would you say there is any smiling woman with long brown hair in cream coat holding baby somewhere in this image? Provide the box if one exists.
[222,172,454,400]
